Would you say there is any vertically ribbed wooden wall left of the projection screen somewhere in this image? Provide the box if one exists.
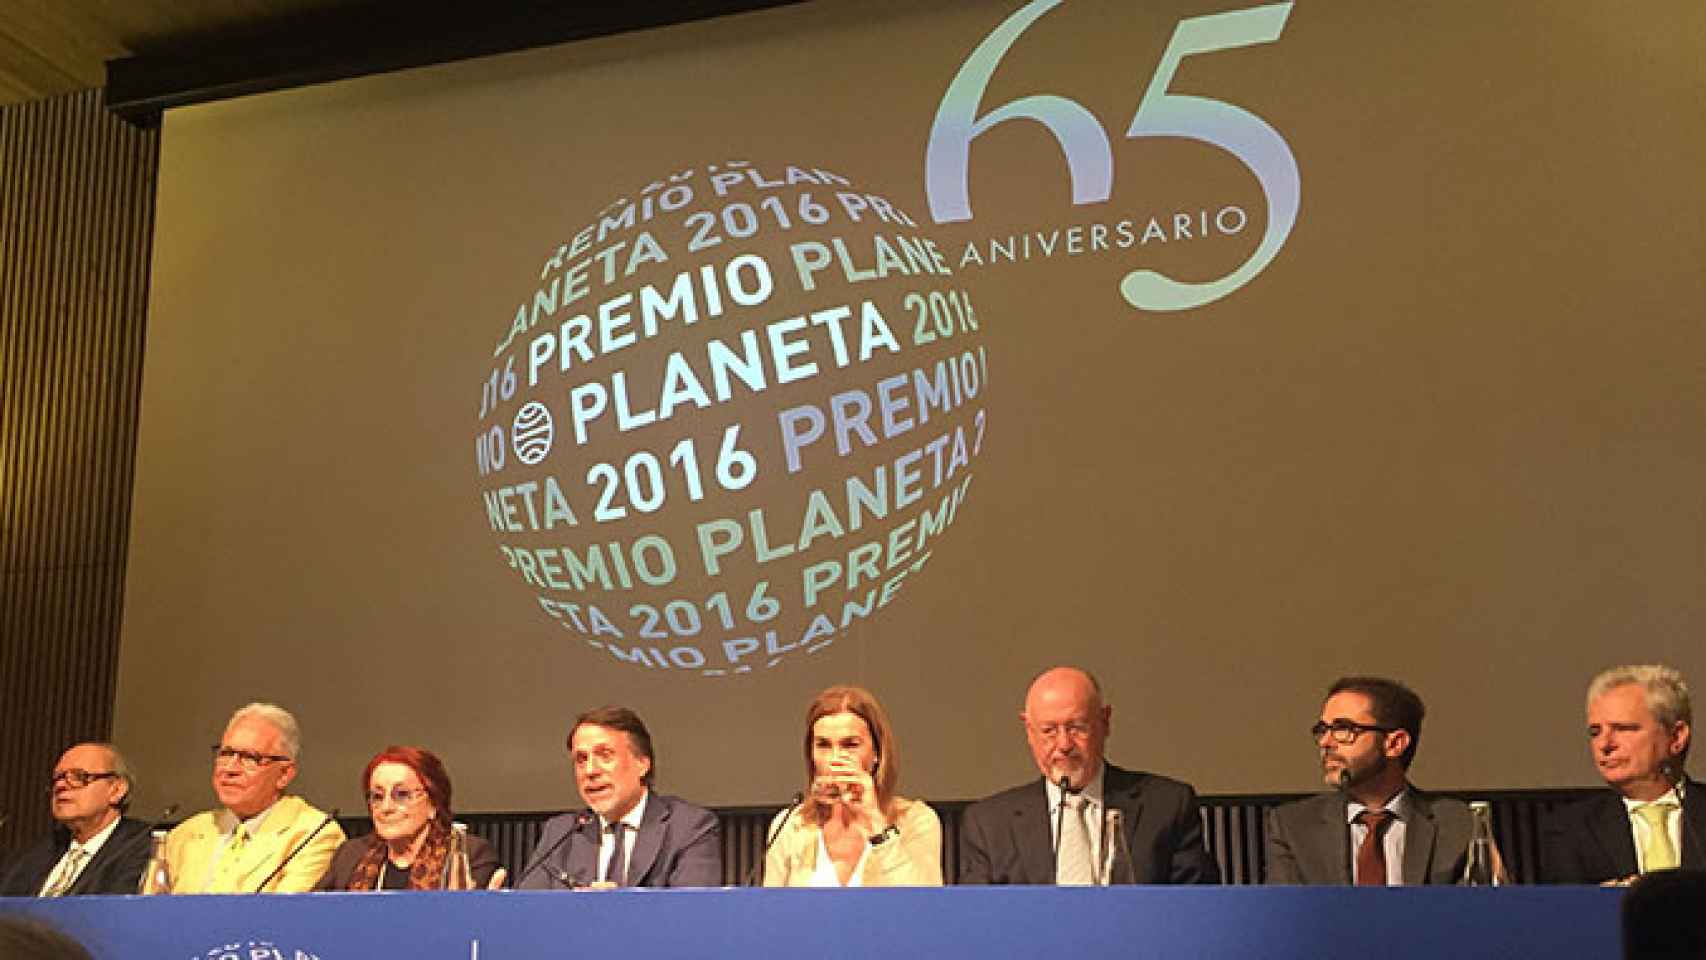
[0,90,159,856]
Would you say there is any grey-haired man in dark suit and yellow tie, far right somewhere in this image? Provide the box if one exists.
[1541,665,1706,883]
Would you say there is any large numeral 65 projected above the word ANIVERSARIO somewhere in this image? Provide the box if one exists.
[925,0,1298,310]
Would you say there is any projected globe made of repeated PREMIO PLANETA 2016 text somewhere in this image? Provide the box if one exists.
[474,160,988,677]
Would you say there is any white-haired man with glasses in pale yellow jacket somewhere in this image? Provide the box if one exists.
[165,703,345,893]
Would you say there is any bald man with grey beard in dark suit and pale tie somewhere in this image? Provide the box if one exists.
[959,667,1220,885]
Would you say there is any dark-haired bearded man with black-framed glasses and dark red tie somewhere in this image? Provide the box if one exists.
[1266,677,1472,887]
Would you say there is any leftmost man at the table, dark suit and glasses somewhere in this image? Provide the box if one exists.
[0,743,150,897]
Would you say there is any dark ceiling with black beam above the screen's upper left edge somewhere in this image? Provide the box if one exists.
[0,0,800,124]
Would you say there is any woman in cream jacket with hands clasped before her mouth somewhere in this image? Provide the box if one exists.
[764,685,942,887]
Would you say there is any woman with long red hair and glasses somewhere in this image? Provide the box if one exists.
[316,747,505,890]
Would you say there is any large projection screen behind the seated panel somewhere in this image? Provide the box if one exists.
[116,0,1706,810]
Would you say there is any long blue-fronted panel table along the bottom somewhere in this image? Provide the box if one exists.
[0,887,1621,960]
